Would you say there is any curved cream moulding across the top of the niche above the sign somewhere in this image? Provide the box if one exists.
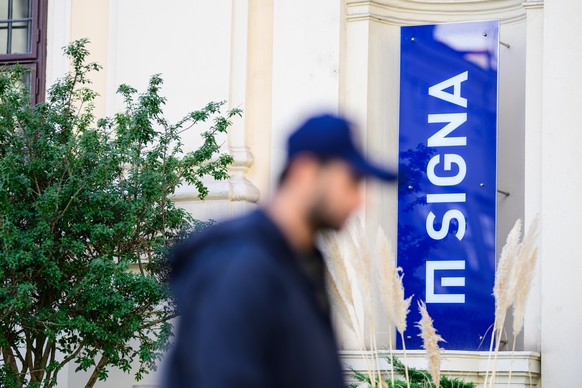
[346,0,525,26]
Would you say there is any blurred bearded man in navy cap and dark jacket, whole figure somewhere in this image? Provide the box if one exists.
[164,115,396,388]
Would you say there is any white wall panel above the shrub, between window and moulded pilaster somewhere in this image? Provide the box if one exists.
[108,0,232,119]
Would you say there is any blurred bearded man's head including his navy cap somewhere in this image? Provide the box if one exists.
[281,115,396,230]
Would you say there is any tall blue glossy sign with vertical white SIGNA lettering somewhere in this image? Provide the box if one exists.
[398,21,499,350]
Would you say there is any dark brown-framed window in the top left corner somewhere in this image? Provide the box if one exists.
[0,0,48,103]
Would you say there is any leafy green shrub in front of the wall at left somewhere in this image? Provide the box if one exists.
[0,40,240,387]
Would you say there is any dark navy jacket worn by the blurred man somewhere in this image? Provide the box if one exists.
[163,211,345,388]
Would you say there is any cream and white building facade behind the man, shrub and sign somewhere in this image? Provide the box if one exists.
[12,0,582,388]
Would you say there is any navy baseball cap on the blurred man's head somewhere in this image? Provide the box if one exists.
[287,114,397,181]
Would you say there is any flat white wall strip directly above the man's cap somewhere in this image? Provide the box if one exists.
[270,0,341,190]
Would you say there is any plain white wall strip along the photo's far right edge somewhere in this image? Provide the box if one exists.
[541,1,582,387]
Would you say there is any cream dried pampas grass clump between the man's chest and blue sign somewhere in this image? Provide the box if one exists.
[320,219,416,386]
